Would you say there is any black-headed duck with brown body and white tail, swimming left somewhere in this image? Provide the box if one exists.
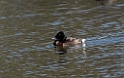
[52,31,85,46]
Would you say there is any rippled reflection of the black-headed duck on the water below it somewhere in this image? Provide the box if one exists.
[55,40,86,63]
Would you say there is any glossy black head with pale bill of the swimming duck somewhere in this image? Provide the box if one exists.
[52,31,67,43]
